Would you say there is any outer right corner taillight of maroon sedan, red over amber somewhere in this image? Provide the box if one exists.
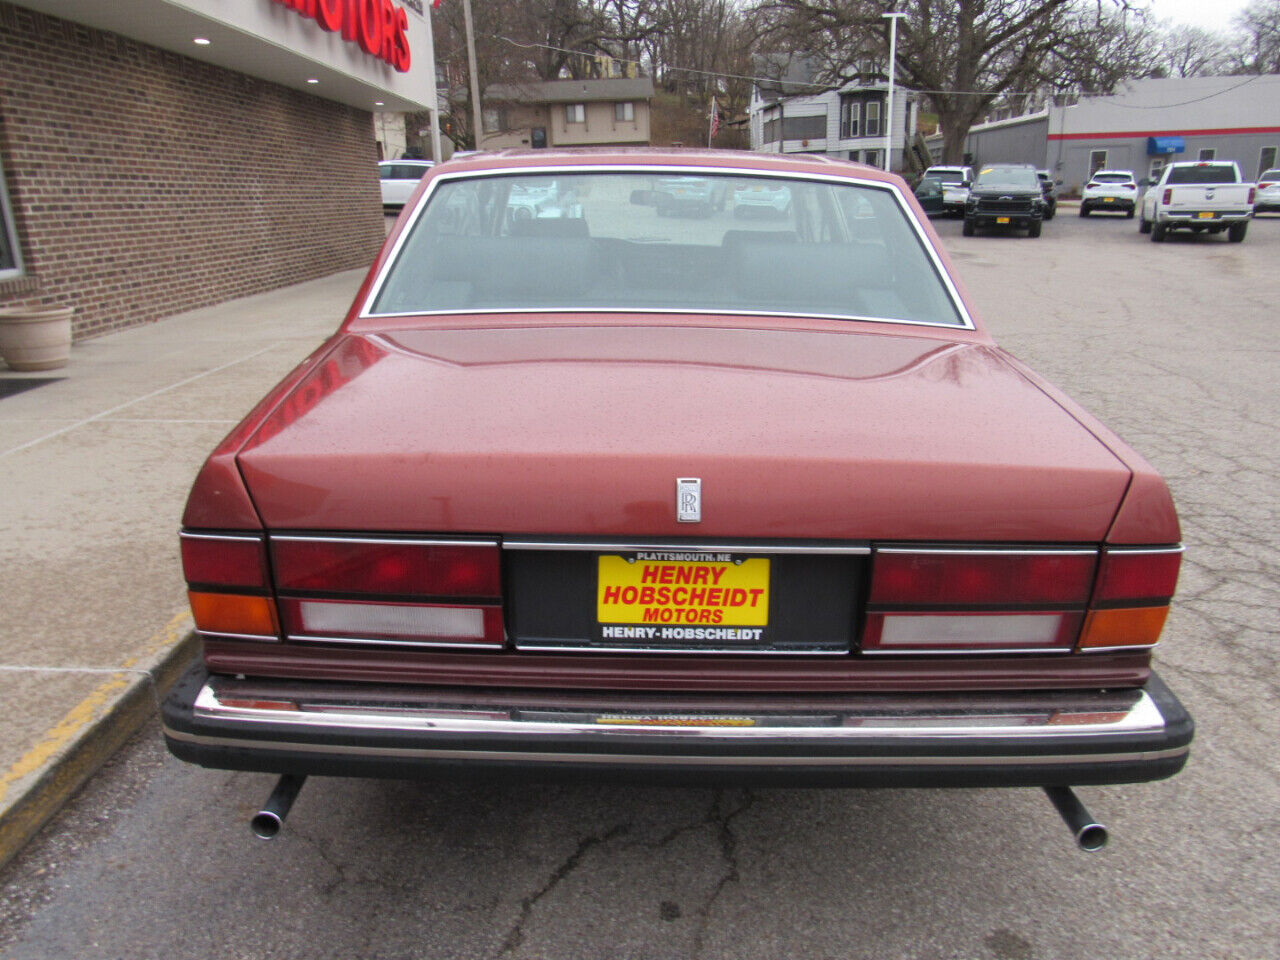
[1079,547,1181,652]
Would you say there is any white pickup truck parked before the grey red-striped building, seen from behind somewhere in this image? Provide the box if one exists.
[1138,160,1257,243]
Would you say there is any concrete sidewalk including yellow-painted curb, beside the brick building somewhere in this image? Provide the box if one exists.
[0,271,364,864]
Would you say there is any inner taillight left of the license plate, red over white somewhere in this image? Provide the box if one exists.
[270,535,506,648]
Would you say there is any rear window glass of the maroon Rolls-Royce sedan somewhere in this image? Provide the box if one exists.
[371,173,964,326]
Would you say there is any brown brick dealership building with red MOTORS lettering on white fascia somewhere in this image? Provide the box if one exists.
[0,0,435,338]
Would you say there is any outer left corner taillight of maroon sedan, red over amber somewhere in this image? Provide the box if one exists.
[182,531,280,641]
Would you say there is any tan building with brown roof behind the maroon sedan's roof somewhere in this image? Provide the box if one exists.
[480,77,653,150]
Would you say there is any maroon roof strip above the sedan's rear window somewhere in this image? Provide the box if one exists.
[430,147,901,183]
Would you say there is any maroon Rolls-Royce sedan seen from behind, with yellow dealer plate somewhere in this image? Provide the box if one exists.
[164,150,1192,845]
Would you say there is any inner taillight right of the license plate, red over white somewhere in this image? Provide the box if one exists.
[863,547,1097,654]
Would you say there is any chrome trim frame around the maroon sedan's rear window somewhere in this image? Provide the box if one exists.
[357,164,978,330]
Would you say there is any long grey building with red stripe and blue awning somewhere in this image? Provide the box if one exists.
[929,74,1280,193]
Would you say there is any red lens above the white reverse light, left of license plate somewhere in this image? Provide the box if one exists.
[271,536,502,598]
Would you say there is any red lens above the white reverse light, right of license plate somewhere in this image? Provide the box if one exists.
[868,548,1096,607]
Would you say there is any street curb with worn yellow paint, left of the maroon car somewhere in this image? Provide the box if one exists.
[0,631,200,868]
